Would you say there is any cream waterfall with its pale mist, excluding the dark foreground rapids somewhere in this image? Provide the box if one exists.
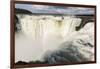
[15,14,94,62]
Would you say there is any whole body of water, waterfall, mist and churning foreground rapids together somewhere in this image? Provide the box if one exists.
[15,14,94,63]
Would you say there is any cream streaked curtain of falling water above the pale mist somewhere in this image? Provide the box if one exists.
[18,15,81,39]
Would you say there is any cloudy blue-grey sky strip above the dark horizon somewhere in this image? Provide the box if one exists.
[15,4,94,15]
